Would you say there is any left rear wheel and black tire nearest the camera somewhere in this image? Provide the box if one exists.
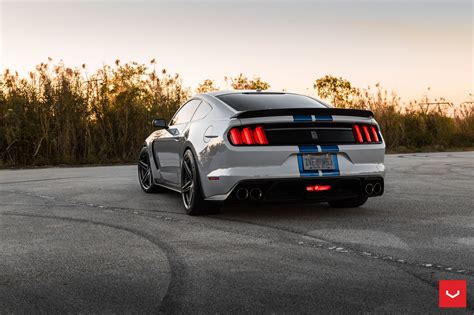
[181,149,221,215]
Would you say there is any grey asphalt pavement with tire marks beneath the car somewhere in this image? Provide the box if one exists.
[0,152,474,314]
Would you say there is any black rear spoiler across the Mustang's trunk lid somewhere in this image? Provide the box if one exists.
[232,108,374,118]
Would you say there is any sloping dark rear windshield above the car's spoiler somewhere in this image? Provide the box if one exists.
[217,93,327,112]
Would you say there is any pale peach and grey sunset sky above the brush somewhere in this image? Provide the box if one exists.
[0,0,474,104]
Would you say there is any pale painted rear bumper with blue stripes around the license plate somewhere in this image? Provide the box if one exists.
[200,144,385,201]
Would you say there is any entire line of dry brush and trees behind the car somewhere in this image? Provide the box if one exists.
[0,60,474,167]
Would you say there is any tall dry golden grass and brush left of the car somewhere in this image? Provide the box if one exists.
[0,61,189,166]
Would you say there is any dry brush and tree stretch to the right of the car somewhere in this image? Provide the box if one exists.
[352,85,474,152]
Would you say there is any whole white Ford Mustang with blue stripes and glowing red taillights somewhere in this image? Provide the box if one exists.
[138,90,385,215]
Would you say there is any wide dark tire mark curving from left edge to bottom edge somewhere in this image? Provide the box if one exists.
[0,212,188,313]
